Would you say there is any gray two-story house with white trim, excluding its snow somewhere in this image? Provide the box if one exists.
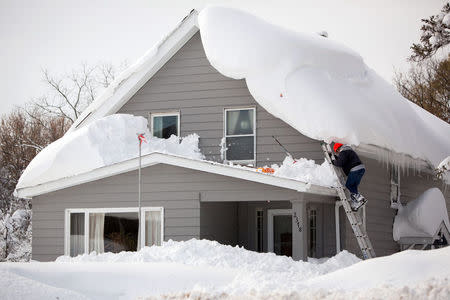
[17,6,450,261]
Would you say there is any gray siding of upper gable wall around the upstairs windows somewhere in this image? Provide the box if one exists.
[118,33,323,166]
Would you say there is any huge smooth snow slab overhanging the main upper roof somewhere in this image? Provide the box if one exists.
[199,7,450,166]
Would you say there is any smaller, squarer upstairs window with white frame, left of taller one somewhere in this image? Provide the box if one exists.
[150,112,180,139]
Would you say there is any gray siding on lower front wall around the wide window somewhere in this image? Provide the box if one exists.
[32,164,327,261]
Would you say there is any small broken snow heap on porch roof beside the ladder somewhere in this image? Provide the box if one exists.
[272,156,338,186]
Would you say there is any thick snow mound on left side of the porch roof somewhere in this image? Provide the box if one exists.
[16,114,204,188]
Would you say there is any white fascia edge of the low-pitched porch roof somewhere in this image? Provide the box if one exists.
[16,152,337,198]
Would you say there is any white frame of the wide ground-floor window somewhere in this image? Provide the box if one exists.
[64,206,164,256]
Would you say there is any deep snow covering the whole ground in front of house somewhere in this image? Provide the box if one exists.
[0,239,450,299]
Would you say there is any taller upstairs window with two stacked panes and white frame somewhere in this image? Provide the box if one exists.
[224,108,256,162]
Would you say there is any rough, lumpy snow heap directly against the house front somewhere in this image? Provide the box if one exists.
[56,239,360,278]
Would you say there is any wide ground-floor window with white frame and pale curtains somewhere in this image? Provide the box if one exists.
[65,207,164,256]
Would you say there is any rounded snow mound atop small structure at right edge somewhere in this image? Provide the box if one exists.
[393,188,450,241]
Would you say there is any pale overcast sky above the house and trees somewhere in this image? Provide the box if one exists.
[0,0,445,115]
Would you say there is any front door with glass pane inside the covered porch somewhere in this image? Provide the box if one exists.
[267,209,292,256]
